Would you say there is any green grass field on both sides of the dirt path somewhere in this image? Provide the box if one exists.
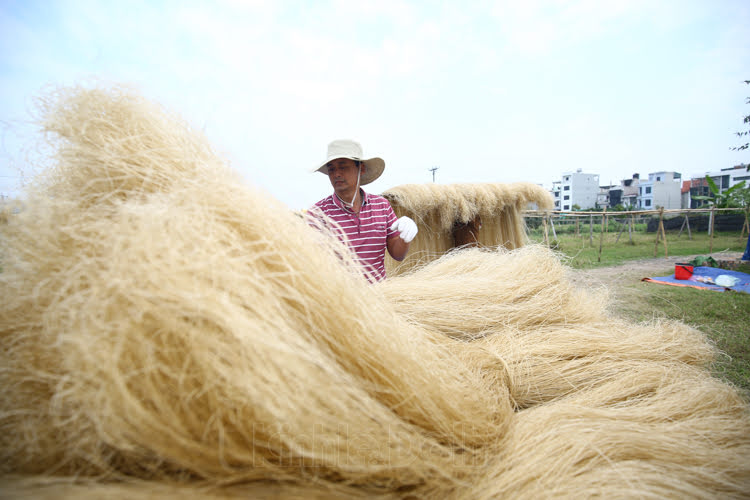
[530,226,750,394]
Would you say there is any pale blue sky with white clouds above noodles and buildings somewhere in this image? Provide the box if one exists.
[0,0,750,209]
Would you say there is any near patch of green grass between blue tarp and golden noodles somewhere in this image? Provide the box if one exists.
[619,280,750,398]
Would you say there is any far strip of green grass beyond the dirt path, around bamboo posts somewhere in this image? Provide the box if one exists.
[529,230,747,269]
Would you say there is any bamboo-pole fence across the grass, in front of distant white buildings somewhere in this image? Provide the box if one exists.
[524,208,750,257]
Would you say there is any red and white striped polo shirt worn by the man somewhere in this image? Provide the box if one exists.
[315,190,398,281]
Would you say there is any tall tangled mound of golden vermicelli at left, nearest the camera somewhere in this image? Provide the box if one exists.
[0,84,512,489]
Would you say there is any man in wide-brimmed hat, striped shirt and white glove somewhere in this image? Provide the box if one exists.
[312,139,418,281]
